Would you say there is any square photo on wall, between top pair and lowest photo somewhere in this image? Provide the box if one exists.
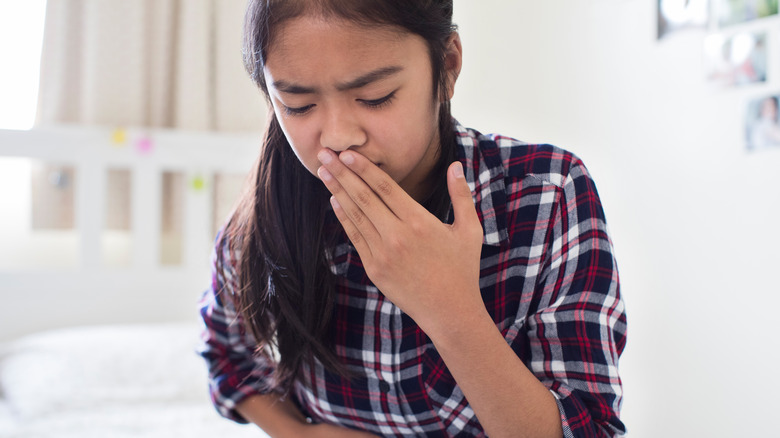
[704,32,767,87]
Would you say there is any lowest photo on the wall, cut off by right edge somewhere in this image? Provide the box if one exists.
[745,95,780,151]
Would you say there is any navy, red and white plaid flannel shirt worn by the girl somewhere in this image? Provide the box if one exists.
[200,119,626,437]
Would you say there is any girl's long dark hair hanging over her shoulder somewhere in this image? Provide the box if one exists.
[217,0,456,392]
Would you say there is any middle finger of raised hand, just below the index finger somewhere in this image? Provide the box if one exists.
[318,149,396,233]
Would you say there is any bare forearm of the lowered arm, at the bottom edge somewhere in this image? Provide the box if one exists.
[236,393,308,438]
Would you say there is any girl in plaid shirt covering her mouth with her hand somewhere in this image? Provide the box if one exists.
[201,0,625,437]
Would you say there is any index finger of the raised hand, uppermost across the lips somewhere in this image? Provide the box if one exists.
[339,151,422,219]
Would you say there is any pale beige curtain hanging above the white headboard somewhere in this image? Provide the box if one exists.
[36,0,266,131]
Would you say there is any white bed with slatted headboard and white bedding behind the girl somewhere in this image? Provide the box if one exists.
[0,127,266,438]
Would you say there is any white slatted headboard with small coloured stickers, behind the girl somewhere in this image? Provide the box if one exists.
[0,127,261,340]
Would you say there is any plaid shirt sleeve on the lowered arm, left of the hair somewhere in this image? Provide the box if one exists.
[198,237,274,423]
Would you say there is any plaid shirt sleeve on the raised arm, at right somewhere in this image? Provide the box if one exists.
[524,160,626,437]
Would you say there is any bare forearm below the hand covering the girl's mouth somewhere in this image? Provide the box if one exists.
[429,312,563,438]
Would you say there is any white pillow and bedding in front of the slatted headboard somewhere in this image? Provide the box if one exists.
[0,324,267,438]
